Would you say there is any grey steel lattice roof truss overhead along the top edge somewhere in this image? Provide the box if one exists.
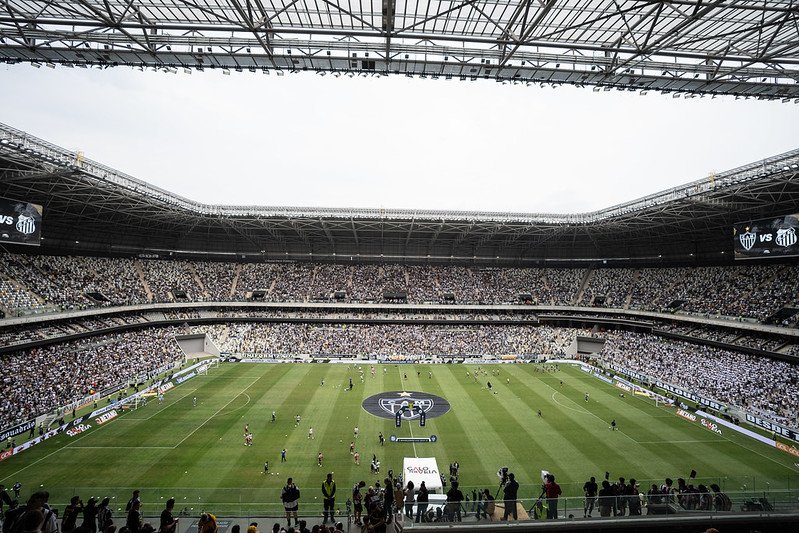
[0,0,799,102]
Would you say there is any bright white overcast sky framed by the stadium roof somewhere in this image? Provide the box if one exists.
[0,64,799,213]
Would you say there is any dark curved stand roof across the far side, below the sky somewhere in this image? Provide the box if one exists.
[0,119,799,266]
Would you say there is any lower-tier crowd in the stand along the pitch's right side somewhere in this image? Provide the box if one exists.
[601,331,799,424]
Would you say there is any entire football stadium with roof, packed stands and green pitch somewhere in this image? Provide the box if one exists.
[0,0,799,533]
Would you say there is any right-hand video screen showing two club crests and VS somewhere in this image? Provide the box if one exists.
[733,213,799,259]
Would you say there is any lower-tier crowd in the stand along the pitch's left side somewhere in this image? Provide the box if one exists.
[0,327,183,428]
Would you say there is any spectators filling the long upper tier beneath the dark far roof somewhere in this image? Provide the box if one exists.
[0,254,799,325]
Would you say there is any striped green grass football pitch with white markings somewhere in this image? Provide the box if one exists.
[0,363,799,516]
